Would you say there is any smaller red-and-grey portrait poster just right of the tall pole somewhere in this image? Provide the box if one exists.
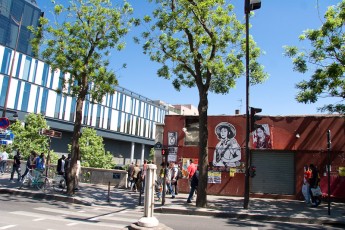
[252,124,272,149]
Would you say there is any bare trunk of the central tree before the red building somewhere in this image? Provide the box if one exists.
[196,91,208,207]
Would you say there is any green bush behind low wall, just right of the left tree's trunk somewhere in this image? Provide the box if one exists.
[68,128,115,169]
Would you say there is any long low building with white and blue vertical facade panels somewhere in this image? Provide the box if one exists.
[0,42,167,163]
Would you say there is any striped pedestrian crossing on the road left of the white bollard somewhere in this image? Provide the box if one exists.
[0,206,143,230]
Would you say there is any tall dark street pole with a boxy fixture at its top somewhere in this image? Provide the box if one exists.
[243,0,261,209]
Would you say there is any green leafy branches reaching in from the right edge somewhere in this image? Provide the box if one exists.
[284,0,345,114]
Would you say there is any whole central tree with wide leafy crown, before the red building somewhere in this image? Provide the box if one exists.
[137,0,267,207]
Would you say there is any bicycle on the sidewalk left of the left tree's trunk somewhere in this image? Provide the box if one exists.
[19,169,50,192]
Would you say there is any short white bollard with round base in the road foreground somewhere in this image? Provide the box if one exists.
[138,164,159,228]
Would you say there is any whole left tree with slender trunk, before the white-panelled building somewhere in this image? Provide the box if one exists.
[31,0,134,194]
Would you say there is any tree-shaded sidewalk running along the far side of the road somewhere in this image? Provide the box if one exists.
[0,174,345,226]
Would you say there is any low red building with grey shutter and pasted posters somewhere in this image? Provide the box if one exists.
[163,115,345,200]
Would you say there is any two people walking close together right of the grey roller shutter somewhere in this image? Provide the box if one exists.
[302,164,322,207]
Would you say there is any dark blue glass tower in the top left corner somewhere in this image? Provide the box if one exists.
[0,0,43,55]
